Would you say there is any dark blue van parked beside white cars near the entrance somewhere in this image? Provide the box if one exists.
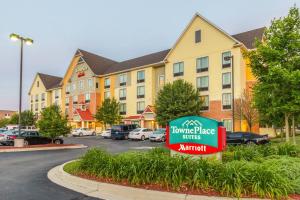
[111,124,139,140]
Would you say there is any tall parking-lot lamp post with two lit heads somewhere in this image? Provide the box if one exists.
[9,33,33,135]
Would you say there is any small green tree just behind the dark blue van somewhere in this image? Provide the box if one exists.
[95,98,121,129]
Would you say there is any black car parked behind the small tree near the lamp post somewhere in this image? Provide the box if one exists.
[20,131,64,146]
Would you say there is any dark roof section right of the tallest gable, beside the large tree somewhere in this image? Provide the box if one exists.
[232,27,266,49]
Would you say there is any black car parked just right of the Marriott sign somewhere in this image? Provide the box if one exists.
[226,132,269,144]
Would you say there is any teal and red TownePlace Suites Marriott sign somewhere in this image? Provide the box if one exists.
[166,116,226,154]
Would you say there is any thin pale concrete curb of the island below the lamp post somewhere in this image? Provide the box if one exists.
[0,144,87,153]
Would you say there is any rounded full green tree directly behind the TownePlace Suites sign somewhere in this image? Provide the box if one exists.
[155,79,202,126]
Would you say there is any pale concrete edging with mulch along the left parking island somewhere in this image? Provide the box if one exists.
[0,144,87,153]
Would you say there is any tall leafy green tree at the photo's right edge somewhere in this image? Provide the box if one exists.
[245,6,300,141]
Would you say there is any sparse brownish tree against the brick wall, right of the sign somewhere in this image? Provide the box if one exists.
[234,90,258,131]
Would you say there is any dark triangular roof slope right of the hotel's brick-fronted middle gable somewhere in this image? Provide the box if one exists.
[78,49,118,75]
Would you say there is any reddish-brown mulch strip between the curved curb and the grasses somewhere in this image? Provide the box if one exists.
[69,173,300,200]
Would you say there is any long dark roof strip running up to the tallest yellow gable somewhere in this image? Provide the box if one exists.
[104,49,170,74]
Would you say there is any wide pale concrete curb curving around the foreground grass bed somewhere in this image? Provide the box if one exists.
[48,160,262,200]
